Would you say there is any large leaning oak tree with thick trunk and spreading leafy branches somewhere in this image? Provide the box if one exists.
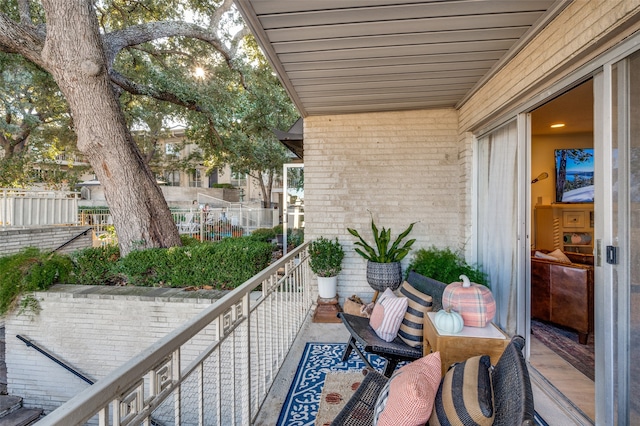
[0,0,296,254]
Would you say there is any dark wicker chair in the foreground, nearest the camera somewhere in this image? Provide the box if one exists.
[331,336,535,426]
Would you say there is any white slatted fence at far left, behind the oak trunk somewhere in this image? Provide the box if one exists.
[0,188,80,228]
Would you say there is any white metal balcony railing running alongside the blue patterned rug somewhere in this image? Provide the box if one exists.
[38,244,313,426]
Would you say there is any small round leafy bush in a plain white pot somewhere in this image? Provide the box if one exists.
[309,237,344,299]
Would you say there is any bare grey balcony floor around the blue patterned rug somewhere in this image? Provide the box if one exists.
[254,308,592,426]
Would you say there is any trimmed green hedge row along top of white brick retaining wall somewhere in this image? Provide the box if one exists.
[0,237,274,315]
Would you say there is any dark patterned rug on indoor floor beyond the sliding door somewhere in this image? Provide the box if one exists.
[531,320,595,380]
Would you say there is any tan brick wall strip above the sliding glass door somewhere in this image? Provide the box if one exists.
[460,0,640,131]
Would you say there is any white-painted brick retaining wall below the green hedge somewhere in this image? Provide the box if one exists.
[5,285,220,413]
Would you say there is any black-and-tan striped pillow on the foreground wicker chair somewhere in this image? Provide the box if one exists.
[429,355,495,426]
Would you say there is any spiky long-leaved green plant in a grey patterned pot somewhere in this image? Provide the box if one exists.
[347,218,416,292]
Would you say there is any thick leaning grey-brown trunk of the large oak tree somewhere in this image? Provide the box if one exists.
[42,0,180,255]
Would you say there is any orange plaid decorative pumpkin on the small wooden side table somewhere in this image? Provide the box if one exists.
[442,275,496,327]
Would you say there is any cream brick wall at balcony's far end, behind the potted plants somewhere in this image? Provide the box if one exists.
[304,109,465,300]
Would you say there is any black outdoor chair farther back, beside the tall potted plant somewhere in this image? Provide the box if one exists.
[338,271,446,377]
